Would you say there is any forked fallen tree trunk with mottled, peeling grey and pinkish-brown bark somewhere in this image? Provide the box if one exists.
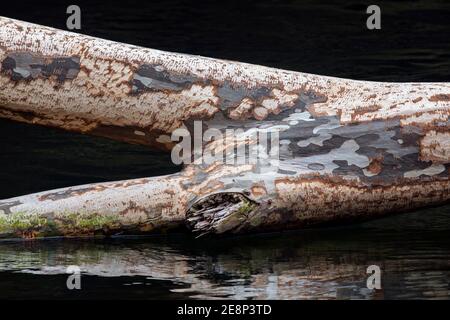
[0,18,450,238]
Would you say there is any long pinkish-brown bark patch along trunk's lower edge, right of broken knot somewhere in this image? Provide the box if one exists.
[267,177,450,227]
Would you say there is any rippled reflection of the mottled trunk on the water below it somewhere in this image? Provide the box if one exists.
[0,207,450,299]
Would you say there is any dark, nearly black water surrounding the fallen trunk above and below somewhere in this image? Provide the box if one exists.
[0,0,450,299]
